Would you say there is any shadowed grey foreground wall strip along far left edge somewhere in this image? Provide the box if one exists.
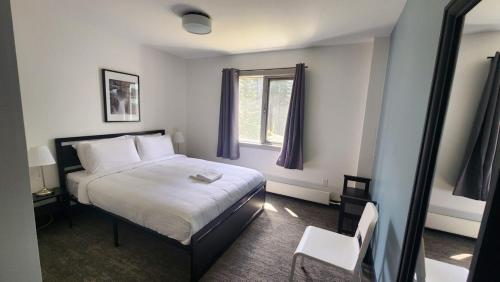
[0,1,42,282]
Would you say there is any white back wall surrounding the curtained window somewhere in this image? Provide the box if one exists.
[187,43,373,198]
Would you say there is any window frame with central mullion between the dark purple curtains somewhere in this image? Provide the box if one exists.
[238,72,295,150]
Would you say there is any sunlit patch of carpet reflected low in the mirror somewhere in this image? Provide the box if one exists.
[424,229,476,268]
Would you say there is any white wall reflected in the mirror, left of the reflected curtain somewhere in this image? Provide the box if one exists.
[434,32,500,189]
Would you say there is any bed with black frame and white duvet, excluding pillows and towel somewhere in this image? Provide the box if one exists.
[55,130,266,281]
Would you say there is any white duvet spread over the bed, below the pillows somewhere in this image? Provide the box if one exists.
[77,155,264,244]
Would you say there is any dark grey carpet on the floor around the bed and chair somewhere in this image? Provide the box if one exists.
[38,194,372,281]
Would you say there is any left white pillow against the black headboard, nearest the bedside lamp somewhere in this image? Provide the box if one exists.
[78,138,141,173]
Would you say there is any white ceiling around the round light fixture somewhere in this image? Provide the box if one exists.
[58,0,406,58]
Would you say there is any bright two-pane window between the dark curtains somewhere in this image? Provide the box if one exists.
[239,72,293,146]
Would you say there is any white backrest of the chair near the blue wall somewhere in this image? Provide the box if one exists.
[354,202,378,269]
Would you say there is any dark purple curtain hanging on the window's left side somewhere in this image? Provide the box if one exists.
[217,69,240,160]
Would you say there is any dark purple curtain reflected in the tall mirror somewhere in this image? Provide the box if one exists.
[453,53,500,201]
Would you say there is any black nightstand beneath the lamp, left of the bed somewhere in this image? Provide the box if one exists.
[32,187,73,228]
